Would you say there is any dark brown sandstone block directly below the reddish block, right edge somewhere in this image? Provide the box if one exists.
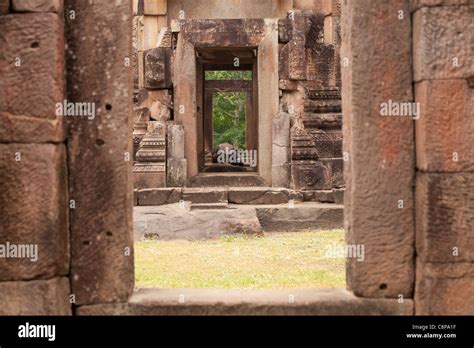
[416,173,474,262]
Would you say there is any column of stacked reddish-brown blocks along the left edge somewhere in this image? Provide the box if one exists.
[0,0,72,315]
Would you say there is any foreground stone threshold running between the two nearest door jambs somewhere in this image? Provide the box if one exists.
[75,289,414,316]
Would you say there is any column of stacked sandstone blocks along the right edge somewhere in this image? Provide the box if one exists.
[412,0,474,315]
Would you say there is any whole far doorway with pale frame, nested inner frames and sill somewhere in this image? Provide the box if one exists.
[174,19,278,187]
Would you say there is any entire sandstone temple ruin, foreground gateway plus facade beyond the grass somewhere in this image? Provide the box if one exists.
[0,0,474,315]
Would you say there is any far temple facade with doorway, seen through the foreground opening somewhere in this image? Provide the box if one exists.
[133,0,344,212]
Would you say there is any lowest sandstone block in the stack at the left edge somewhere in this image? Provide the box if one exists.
[0,278,72,316]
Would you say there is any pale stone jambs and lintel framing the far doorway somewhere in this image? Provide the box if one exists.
[172,19,278,186]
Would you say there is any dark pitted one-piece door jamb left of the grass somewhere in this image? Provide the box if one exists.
[67,0,134,305]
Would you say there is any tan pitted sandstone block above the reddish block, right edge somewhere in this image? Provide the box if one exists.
[413,6,474,82]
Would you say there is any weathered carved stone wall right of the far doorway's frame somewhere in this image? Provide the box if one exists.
[279,1,344,198]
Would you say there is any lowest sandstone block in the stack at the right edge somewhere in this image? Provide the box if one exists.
[415,259,474,315]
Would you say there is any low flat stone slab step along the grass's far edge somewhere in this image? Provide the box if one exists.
[133,202,344,240]
